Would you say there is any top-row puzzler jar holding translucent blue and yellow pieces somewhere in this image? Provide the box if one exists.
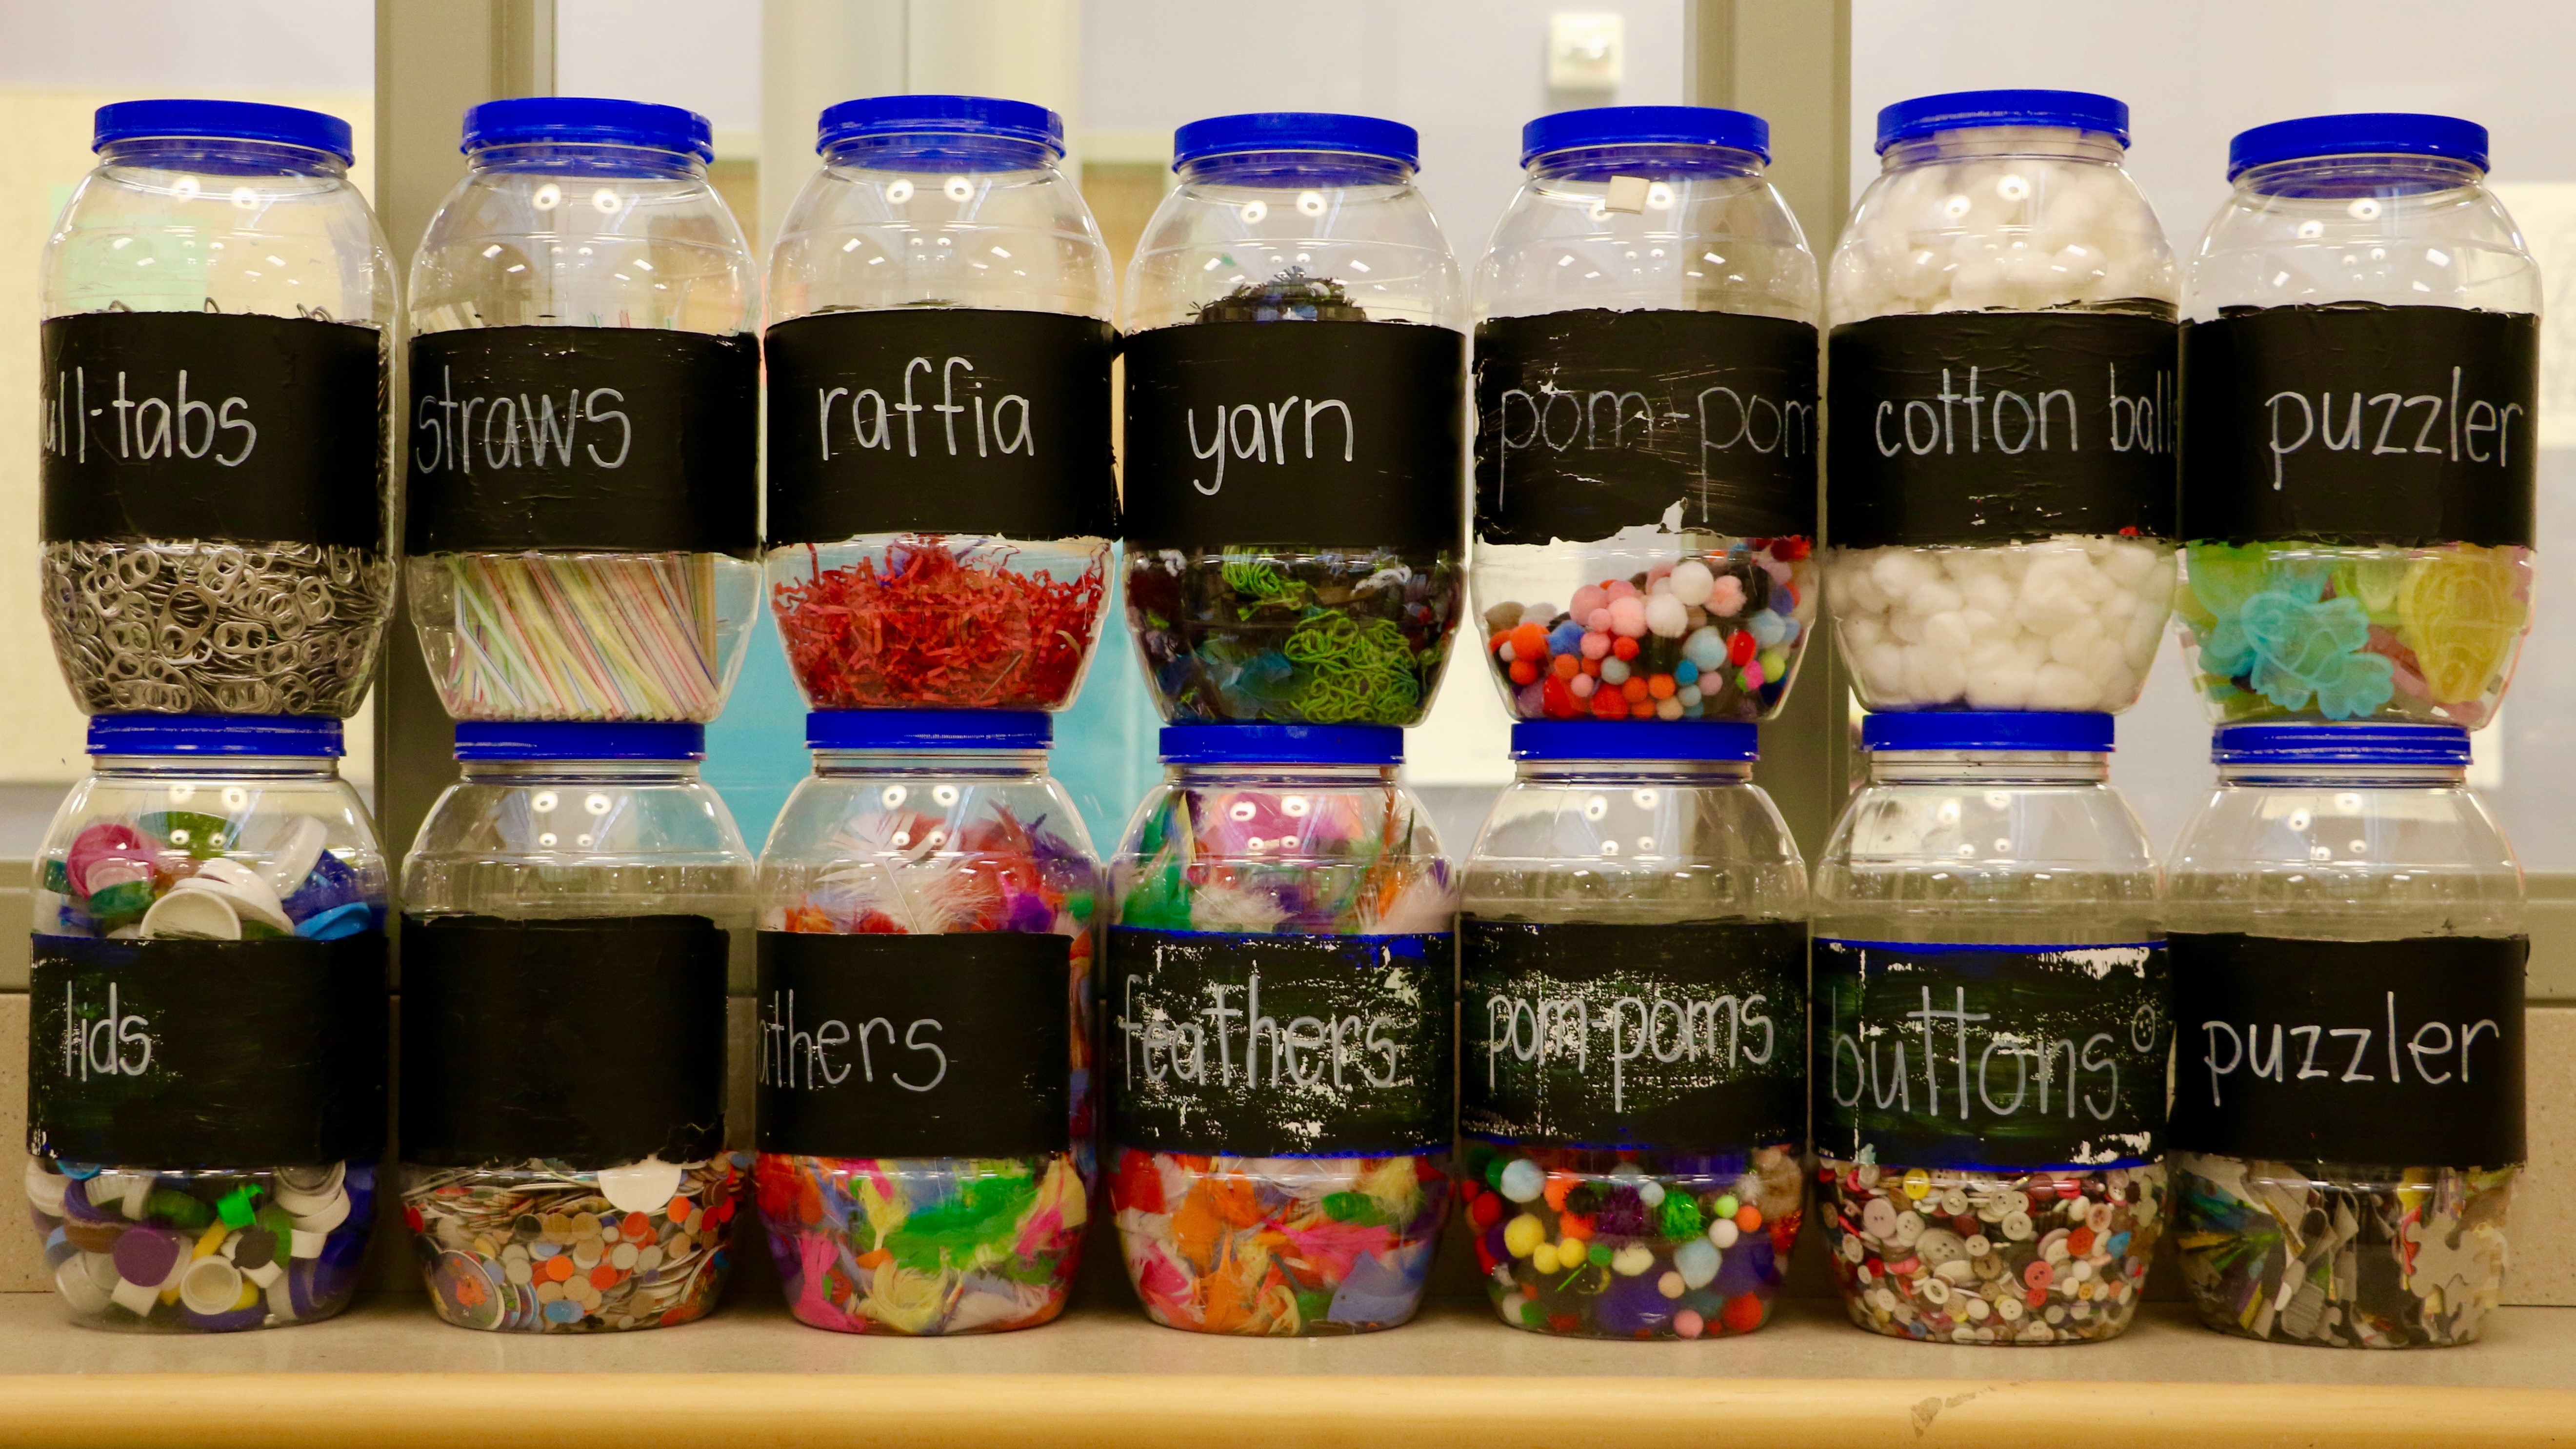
[2177,116,2540,728]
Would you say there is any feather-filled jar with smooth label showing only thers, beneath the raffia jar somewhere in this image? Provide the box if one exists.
[755,710,1100,1336]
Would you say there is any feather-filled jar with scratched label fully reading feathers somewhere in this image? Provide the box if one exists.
[1102,726,1458,1336]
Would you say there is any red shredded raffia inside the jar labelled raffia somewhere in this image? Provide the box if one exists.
[776,533,1108,710]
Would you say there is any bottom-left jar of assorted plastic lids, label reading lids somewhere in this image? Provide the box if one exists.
[26,715,386,1333]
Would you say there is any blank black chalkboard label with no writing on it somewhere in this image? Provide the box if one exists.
[402,916,726,1171]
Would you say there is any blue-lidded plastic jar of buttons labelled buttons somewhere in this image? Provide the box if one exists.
[1808,710,2172,1344]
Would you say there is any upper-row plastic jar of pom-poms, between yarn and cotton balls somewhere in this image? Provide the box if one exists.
[1474,105,1818,721]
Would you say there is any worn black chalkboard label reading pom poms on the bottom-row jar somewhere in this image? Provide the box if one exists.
[1458,916,1806,1151]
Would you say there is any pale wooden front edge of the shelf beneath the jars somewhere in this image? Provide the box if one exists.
[0,1372,2576,1449]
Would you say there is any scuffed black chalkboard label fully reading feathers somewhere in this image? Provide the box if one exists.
[1100,927,1458,1158]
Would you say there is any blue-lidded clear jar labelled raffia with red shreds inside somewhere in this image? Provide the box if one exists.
[765,95,1118,710]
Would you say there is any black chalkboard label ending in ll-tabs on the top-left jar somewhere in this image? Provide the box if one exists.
[41,312,389,551]
